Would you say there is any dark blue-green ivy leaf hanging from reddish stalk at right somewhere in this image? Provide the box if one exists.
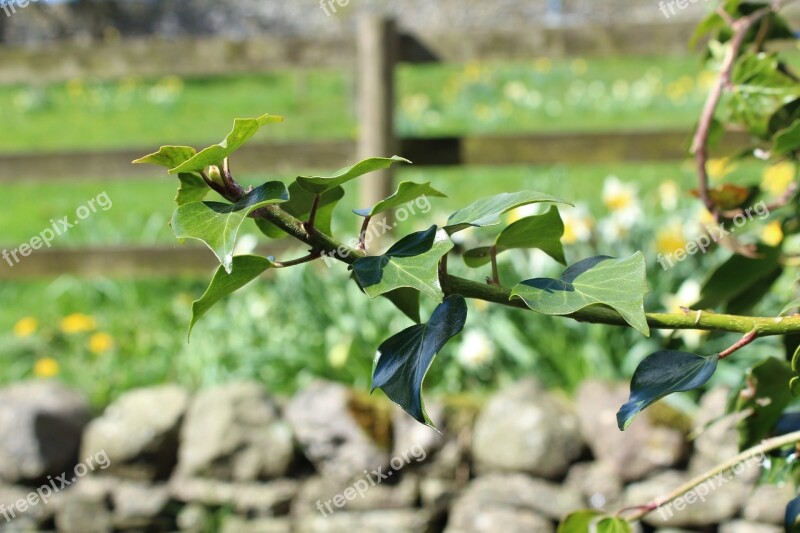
[617,350,719,431]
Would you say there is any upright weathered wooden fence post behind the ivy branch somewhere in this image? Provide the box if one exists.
[357,14,399,243]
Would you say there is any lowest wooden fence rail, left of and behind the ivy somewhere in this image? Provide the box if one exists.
[0,241,290,281]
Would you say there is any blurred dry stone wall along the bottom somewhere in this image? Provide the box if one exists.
[0,381,793,533]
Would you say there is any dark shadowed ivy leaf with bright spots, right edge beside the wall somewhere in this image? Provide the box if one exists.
[736,357,793,450]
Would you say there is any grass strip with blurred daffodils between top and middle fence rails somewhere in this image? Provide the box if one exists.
[0,56,720,153]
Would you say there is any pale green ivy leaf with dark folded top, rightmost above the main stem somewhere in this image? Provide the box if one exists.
[511,252,650,336]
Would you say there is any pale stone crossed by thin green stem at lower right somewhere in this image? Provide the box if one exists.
[624,470,752,527]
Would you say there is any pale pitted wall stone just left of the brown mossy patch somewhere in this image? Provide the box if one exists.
[286,381,389,485]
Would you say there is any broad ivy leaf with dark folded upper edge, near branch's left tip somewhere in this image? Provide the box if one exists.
[172,181,289,274]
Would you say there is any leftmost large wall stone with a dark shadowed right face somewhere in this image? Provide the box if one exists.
[0,381,90,483]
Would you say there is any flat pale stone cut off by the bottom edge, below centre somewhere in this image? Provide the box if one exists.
[295,510,432,533]
